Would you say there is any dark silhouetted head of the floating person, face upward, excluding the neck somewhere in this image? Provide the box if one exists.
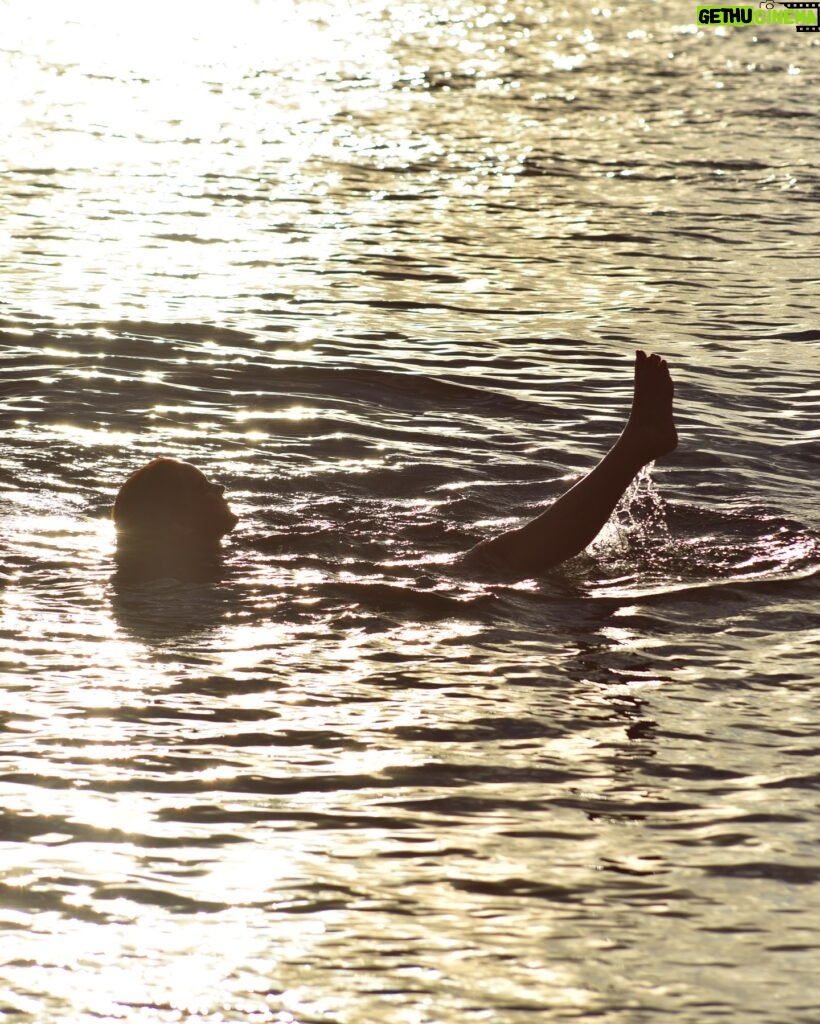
[112,459,239,554]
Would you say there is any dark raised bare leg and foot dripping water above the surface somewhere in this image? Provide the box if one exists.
[463,351,678,580]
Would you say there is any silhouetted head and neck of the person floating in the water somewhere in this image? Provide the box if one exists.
[112,459,239,580]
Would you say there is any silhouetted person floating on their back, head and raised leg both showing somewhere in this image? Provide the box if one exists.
[112,351,678,580]
